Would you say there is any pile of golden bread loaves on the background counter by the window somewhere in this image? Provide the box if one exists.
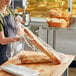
[47,8,71,28]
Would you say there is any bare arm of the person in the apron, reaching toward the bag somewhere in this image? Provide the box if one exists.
[0,31,22,45]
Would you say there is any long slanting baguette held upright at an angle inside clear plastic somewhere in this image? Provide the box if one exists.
[24,27,61,64]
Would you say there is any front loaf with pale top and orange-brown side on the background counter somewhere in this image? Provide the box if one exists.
[47,18,68,28]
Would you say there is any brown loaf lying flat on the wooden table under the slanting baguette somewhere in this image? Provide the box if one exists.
[19,51,51,63]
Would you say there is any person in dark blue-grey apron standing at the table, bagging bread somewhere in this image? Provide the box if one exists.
[0,0,22,65]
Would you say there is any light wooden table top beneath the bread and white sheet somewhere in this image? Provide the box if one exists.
[0,52,74,76]
